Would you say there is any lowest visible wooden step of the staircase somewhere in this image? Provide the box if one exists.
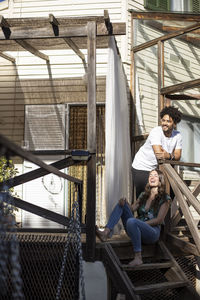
[134,281,188,294]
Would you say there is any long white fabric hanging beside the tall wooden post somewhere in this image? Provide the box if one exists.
[105,37,131,223]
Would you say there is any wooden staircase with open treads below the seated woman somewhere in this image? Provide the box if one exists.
[103,241,200,300]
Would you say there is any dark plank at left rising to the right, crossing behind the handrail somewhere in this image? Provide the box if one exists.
[0,157,75,190]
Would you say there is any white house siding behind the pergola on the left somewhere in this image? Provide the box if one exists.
[0,0,125,144]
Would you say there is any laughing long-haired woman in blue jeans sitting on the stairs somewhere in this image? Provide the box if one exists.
[96,169,171,267]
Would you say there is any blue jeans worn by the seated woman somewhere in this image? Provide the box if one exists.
[106,203,160,252]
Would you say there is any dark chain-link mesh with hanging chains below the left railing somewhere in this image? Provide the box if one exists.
[0,192,85,300]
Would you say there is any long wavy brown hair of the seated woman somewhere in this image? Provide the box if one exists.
[139,169,166,213]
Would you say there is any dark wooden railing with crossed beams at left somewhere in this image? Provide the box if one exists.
[0,135,86,232]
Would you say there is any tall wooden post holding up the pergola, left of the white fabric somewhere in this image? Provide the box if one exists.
[86,22,96,261]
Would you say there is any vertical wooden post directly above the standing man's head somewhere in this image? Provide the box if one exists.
[158,41,164,124]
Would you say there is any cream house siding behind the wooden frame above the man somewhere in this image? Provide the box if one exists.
[127,0,200,133]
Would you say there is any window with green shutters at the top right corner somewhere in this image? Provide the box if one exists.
[144,0,200,13]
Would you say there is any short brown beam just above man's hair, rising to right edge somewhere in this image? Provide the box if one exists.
[160,79,200,95]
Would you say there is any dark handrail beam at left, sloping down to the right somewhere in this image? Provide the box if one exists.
[0,134,82,184]
